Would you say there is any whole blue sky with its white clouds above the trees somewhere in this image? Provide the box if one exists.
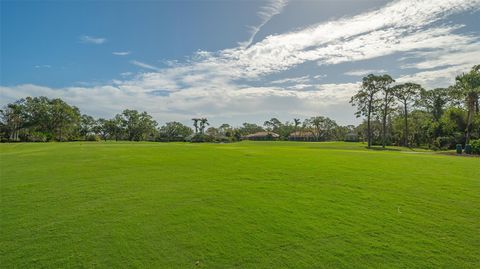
[0,0,480,125]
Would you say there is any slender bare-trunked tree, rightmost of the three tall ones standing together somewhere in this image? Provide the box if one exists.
[393,82,422,147]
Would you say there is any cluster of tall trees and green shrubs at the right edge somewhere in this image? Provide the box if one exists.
[350,65,480,149]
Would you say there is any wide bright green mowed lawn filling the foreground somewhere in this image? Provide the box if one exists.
[0,142,480,268]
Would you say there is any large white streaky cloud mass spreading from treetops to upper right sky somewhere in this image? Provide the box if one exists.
[0,0,480,123]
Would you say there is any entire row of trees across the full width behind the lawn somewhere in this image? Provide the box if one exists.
[0,65,480,149]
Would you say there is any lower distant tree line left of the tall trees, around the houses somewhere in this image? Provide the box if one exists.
[0,96,355,142]
